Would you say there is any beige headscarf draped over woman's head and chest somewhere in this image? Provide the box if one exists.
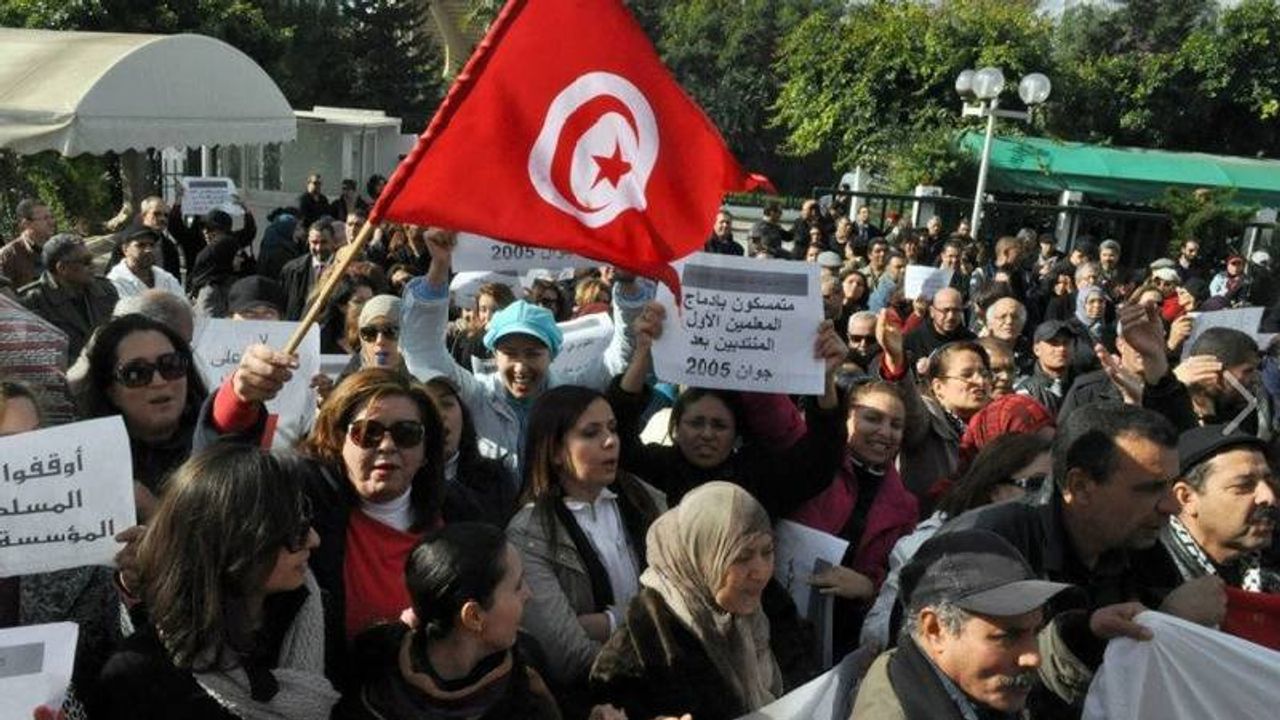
[640,483,782,710]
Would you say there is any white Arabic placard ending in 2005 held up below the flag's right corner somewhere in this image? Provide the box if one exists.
[653,252,823,395]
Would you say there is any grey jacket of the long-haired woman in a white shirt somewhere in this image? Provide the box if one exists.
[507,480,667,684]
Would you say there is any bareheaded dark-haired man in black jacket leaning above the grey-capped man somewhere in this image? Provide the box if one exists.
[940,402,1226,711]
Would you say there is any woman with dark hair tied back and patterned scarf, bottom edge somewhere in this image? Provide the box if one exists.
[334,523,561,720]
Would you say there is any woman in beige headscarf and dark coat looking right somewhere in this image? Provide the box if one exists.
[591,482,788,720]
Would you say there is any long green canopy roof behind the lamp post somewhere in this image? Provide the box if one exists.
[960,132,1280,208]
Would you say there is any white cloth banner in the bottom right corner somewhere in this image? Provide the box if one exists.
[1083,611,1280,720]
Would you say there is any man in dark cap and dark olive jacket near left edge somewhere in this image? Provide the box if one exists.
[20,233,118,357]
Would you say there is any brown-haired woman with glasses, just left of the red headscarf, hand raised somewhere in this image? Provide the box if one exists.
[876,311,992,512]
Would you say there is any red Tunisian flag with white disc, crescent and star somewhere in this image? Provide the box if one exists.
[370,0,768,296]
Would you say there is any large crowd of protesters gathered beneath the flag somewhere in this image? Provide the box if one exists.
[0,176,1280,720]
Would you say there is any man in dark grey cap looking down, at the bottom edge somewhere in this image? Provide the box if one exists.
[852,530,1144,720]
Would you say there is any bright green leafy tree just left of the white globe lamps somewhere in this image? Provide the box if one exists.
[776,0,1052,187]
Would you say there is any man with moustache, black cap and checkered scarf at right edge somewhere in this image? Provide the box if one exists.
[1160,425,1280,593]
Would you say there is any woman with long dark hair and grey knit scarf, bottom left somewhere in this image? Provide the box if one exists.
[88,445,338,720]
